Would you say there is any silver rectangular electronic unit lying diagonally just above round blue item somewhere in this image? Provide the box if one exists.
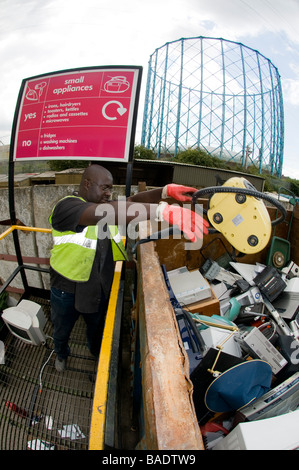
[236,327,288,374]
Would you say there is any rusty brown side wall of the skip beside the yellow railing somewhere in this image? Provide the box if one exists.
[137,224,204,450]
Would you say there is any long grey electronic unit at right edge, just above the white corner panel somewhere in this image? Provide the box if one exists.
[234,372,299,425]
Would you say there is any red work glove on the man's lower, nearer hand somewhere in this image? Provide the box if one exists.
[156,202,209,242]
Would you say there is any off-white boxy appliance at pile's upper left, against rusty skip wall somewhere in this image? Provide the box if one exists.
[167,266,211,306]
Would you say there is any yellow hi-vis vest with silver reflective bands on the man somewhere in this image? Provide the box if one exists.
[49,196,128,282]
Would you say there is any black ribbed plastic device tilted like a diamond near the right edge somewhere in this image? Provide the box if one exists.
[253,266,287,302]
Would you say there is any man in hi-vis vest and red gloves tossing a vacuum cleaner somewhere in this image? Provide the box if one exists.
[49,164,208,372]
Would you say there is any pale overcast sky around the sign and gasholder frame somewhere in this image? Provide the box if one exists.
[0,0,299,179]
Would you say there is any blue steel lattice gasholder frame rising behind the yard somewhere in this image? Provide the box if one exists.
[141,36,284,176]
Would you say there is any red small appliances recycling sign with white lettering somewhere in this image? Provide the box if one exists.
[13,66,142,162]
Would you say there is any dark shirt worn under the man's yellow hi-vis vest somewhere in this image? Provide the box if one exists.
[50,197,114,313]
